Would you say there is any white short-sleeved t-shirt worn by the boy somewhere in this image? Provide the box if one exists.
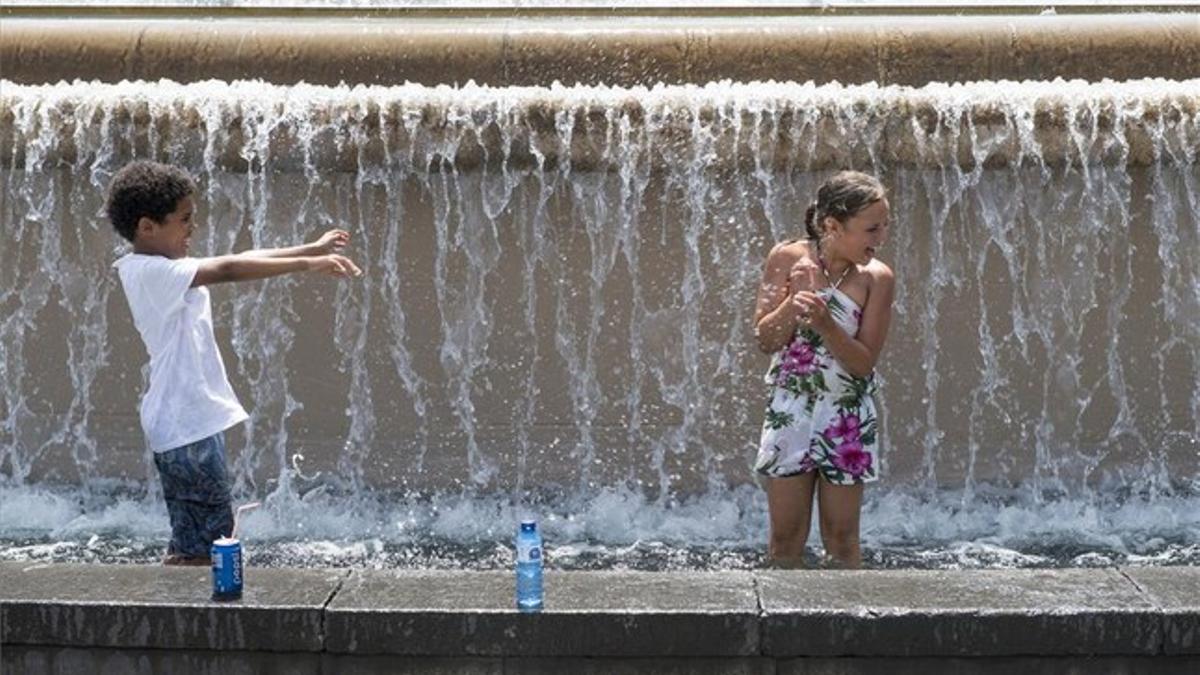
[113,253,248,453]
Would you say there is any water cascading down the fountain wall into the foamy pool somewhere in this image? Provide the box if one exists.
[0,80,1200,566]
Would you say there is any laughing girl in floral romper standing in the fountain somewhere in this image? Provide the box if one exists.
[755,172,895,568]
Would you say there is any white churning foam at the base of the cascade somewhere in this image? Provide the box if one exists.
[0,478,1200,568]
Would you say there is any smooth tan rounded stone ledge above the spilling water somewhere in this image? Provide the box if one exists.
[0,12,1200,86]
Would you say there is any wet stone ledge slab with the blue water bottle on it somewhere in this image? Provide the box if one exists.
[325,571,760,657]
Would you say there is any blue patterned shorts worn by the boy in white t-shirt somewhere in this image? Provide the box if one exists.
[154,434,233,557]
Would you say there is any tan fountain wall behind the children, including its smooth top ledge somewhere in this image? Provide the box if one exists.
[0,13,1200,491]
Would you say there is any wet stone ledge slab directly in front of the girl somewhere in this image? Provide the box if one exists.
[756,569,1162,657]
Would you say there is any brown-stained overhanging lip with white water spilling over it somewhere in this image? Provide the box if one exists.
[0,78,1200,177]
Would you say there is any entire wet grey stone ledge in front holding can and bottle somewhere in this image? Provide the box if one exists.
[0,562,1200,673]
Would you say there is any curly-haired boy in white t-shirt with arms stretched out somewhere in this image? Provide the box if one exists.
[106,161,362,565]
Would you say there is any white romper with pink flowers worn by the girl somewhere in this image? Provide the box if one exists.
[755,283,880,485]
